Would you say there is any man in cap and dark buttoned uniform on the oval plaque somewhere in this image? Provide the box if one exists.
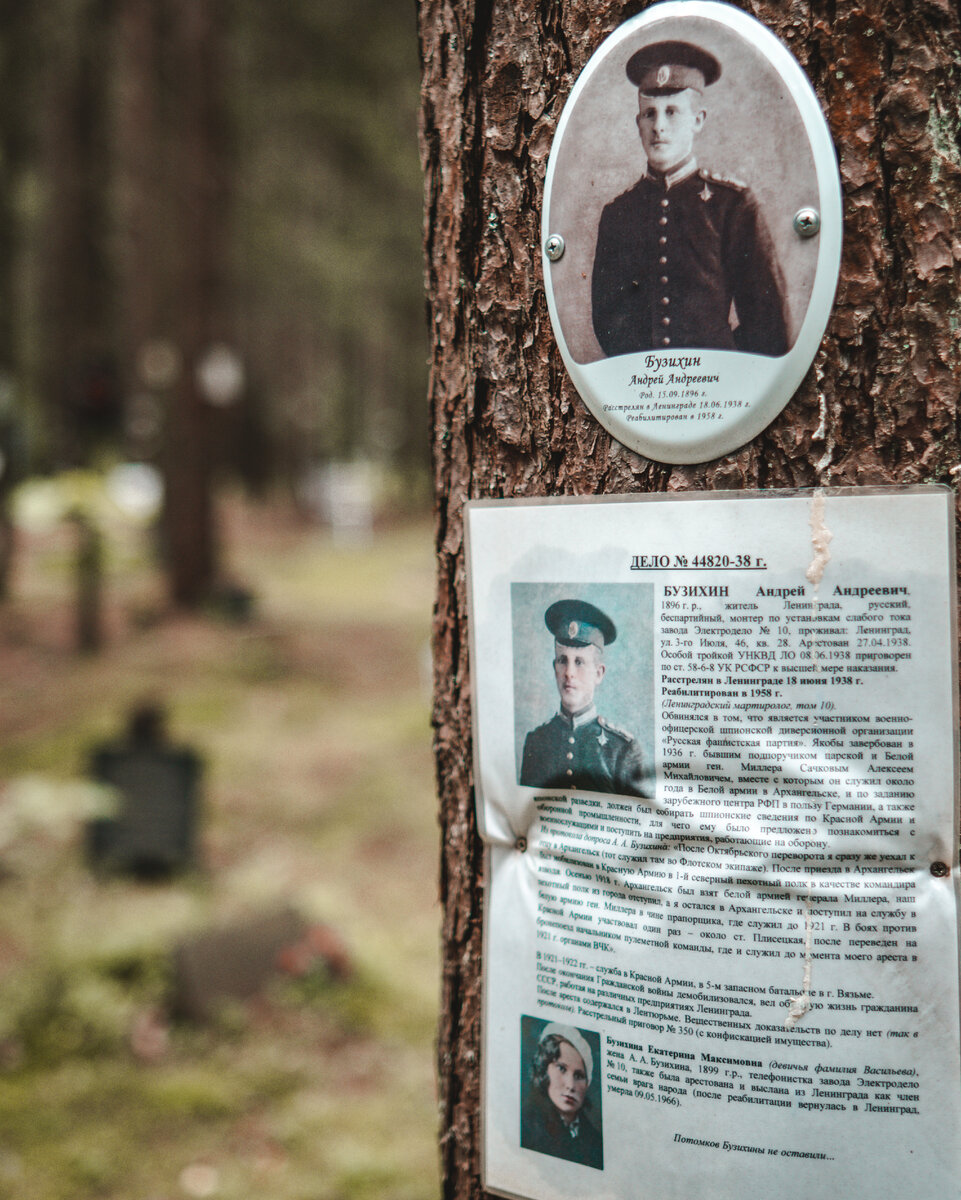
[591,42,789,358]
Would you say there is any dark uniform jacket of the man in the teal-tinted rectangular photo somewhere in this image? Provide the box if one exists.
[521,709,647,796]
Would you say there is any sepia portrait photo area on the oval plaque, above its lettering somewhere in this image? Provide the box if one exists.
[548,16,818,364]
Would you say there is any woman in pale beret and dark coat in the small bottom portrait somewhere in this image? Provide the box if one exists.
[521,1022,603,1170]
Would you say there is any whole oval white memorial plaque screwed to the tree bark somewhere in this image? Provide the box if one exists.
[541,0,841,463]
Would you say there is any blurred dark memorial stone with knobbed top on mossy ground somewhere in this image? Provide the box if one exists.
[86,704,203,878]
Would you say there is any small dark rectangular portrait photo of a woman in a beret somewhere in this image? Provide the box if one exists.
[521,1016,603,1171]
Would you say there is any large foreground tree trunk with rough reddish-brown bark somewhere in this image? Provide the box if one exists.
[419,0,961,1198]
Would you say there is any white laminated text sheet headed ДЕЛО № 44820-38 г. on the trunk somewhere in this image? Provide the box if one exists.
[467,487,961,1200]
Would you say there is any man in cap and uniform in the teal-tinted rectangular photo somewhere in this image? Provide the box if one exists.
[521,600,648,796]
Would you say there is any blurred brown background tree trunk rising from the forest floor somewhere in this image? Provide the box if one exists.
[164,0,228,605]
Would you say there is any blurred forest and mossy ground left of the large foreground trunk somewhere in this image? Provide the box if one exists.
[0,0,439,1200]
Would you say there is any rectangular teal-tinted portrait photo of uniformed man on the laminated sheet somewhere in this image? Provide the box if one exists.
[511,583,654,798]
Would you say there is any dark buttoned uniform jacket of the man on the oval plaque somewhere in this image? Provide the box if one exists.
[591,160,788,356]
